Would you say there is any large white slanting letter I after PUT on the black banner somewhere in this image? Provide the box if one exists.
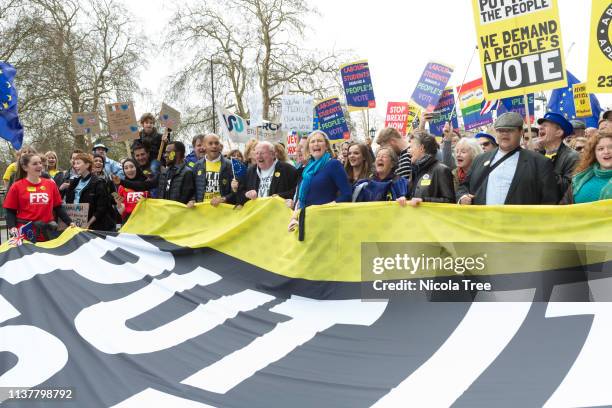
[372,289,535,408]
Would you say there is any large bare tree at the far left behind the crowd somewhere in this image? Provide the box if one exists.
[2,0,144,160]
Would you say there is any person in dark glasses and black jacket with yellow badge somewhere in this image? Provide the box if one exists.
[400,132,455,206]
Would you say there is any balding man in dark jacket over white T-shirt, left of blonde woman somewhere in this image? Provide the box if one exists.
[238,141,297,203]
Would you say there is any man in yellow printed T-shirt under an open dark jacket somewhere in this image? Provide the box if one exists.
[189,133,236,207]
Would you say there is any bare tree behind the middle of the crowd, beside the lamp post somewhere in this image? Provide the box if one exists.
[165,0,340,133]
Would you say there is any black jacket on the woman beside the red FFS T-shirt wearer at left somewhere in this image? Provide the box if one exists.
[66,174,116,231]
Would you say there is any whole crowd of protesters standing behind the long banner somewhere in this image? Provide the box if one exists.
[3,111,612,240]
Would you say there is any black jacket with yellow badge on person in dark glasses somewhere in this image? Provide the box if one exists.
[408,155,455,203]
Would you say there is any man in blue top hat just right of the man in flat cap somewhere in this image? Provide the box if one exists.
[538,112,580,197]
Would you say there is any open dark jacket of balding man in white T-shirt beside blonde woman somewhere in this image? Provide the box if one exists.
[238,160,298,204]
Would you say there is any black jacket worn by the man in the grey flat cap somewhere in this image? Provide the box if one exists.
[457,149,560,205]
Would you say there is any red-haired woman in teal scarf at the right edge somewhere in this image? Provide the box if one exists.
[563,132,612,204]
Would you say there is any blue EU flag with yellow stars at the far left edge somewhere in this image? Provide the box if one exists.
[0,62,23,150]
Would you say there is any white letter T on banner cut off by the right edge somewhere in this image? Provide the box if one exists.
[544,271,612,407]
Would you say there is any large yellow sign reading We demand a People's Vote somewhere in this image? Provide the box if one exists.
[472,0,567,100]
